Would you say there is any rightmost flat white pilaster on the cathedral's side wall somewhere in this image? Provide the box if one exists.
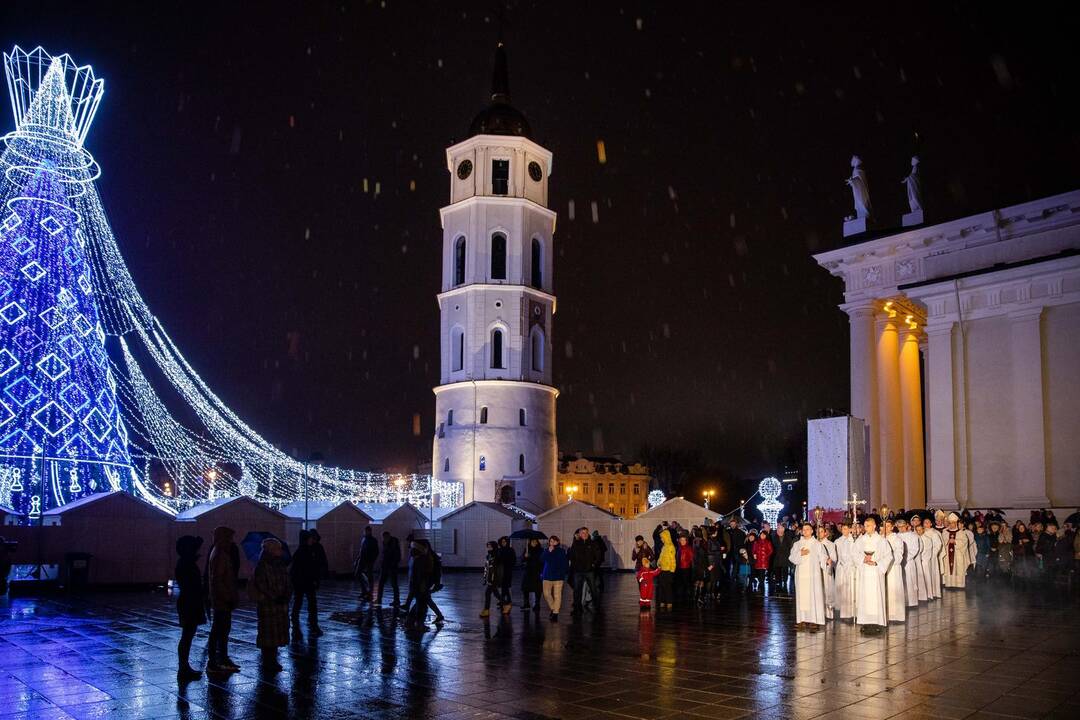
[1009,308,1051,507]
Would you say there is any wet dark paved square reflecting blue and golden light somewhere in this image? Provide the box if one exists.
[0,574,1080,720]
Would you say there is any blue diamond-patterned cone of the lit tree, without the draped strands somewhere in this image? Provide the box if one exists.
[0,57,132,519]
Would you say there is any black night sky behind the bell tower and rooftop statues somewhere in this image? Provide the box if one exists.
[0,0,1080,477]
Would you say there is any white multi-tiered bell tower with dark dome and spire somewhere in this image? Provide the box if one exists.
[432,43,558,512]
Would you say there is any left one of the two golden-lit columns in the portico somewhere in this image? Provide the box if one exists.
[870,317,904,507]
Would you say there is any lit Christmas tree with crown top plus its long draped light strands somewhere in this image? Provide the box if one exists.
[0,46,464,516]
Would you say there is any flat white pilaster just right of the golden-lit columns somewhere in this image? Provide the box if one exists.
[927,321,963,507]
